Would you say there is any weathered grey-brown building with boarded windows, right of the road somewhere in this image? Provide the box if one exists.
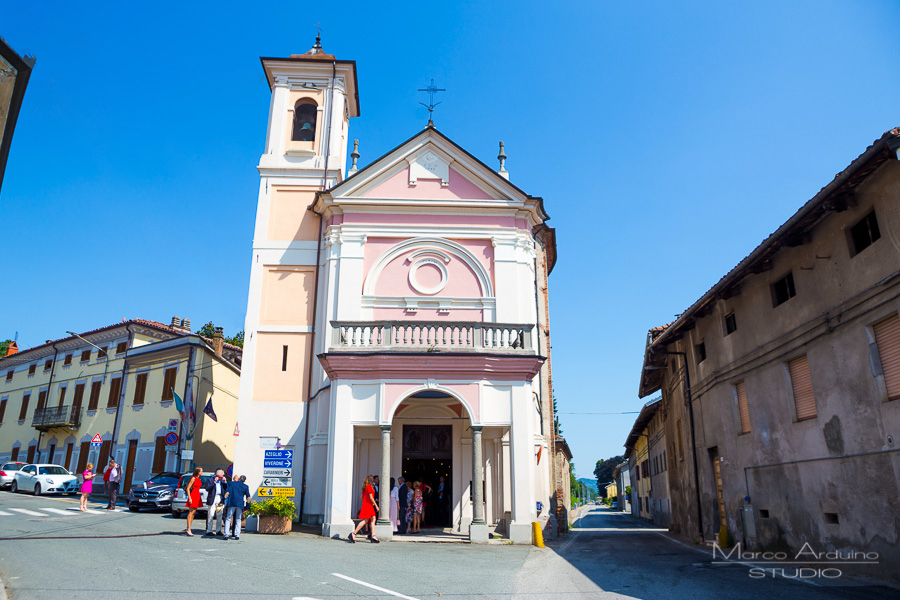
[639,129,900,577]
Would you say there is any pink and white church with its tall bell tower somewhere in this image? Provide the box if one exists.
[236,41,568,543]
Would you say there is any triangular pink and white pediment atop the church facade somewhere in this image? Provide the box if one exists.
[330,127,528,206]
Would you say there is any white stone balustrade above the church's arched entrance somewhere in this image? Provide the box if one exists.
[331,321,534,354]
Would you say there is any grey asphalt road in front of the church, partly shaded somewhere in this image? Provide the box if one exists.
[0,492,900,600]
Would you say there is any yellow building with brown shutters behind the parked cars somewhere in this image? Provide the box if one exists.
[0,317,241,492]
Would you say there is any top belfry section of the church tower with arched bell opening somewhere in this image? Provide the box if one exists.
[259,36,359,188]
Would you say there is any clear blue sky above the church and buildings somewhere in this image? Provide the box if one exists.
[0,0,900,476]
